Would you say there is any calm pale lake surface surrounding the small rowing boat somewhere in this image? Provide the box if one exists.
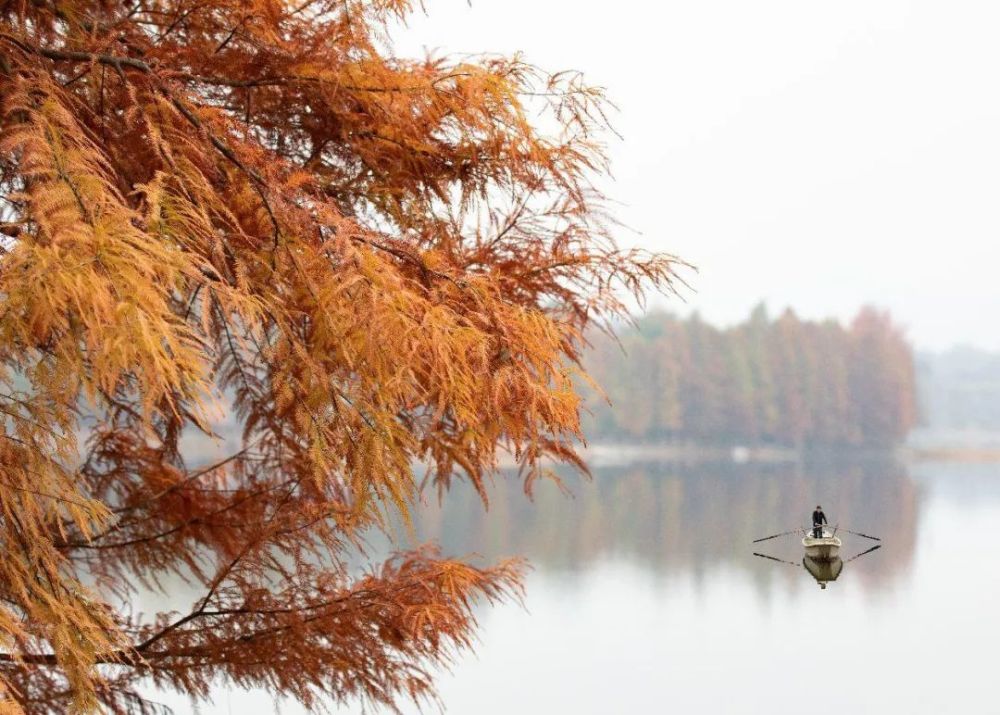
[156,462,1000,715]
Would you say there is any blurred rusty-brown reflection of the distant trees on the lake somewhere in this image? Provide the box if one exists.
[398,460,920,588]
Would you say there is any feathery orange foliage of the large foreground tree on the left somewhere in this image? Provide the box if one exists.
[0,0,674,713]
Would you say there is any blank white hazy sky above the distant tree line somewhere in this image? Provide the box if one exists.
[396,0,1000,349]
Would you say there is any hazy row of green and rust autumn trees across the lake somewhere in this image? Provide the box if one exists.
[585,306,917,447]
